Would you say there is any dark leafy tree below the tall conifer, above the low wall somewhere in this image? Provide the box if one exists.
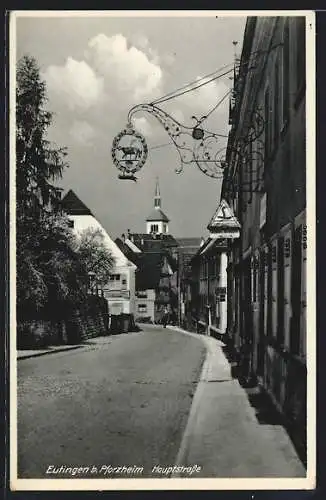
[17,212,87,314]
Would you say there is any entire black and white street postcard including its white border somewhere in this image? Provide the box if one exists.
[9,10,316,491]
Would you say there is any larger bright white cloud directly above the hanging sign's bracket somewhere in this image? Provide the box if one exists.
[86,34,163,102]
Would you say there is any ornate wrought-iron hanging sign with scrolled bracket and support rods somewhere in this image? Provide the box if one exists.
[112,48,265,182]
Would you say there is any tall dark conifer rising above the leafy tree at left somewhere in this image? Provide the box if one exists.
[16,56,68,219]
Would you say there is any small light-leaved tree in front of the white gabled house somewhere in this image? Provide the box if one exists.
[78,228,115,287]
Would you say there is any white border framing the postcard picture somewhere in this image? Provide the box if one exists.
[9,10,316,491]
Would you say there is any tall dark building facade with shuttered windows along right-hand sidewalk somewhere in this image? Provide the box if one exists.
[222,16,307,460]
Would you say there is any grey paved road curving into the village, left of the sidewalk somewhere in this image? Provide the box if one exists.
[18,328,205,479]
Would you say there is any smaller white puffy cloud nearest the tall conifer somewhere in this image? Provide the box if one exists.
[44,57,103,109]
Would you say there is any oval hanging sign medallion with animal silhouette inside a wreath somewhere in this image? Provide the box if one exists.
[112,124,148,174]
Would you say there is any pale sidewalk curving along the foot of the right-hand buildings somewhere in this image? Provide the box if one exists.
[169,327,306,478]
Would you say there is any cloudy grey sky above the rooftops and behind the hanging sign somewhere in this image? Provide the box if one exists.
[16,11,246,238]
